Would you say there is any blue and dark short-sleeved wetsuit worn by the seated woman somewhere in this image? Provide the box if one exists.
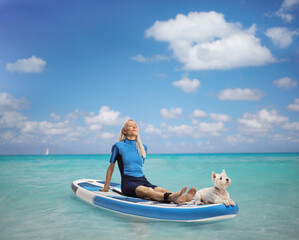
[110,139,157,197]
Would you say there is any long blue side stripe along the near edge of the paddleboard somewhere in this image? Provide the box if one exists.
[94,196,238,221]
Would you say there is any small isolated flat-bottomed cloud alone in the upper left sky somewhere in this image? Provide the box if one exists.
[6,55,47,73]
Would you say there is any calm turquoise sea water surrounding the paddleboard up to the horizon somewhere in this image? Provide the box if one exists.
[0,153,299,240]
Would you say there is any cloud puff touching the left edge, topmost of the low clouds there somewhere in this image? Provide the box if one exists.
[0,92,29,112]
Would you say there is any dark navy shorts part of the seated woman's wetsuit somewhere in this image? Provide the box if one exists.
[121,175,157,197]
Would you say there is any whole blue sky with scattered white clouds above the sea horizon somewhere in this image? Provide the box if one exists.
[0,0,299,154]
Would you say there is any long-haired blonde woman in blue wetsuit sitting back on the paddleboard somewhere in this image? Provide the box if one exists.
[101,119,196,203]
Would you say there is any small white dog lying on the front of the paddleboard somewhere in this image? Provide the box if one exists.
[191,170,236,206]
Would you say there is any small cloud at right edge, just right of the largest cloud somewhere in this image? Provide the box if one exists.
[266,27,299,48]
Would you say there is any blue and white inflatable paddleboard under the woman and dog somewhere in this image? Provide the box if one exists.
[71,179,239,222]
